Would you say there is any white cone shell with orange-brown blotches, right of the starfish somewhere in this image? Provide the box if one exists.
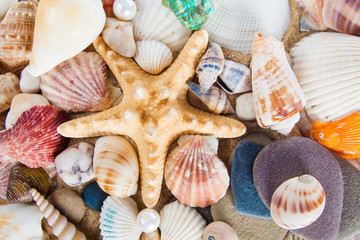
[252,34,305,135]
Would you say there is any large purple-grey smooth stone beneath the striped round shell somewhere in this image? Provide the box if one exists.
[253,137,344,240]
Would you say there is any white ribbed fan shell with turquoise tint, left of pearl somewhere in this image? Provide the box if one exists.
[100,196,141,240]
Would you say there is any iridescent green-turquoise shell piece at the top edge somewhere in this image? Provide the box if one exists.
[161,0,217,30]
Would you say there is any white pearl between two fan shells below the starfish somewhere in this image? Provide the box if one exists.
[136,208,160,233]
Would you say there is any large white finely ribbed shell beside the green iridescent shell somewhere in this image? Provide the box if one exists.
[203,0,290,53]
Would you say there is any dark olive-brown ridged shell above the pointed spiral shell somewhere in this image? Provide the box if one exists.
[6,163,51,203]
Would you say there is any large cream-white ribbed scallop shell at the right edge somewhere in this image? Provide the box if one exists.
[290,32,360,122]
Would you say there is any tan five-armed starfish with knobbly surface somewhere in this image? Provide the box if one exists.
[58,30,246,208]
